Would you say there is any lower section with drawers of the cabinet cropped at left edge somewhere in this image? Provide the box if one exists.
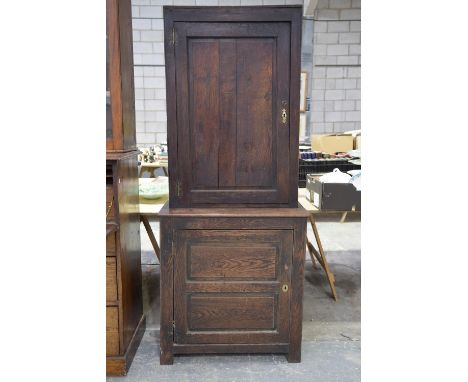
[106,152,145,375]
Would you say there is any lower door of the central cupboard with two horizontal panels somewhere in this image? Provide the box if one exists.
[174,230,293,344]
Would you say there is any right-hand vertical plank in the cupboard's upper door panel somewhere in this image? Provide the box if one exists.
[236,38,276,187]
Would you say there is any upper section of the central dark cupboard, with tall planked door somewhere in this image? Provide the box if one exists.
[164,7,302,207]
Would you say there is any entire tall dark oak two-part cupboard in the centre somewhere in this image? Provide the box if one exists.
[159,7,308,364]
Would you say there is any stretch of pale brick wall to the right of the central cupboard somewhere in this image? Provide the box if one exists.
[311,0,361,134]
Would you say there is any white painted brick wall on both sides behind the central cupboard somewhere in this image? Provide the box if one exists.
[132,0,360,146]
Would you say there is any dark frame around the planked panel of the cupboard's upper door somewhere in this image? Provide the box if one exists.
[175,23,290,205]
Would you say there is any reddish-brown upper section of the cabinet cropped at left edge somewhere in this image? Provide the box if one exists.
[106,0,136,152]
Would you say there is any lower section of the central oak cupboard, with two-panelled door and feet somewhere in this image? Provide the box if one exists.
[160,208,306,364]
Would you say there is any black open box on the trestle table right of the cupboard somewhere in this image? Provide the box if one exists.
[306,174,361,211]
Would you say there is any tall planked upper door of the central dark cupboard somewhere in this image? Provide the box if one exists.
[171,22,290,206]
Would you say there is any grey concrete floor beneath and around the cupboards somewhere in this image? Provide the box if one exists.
[107,216,361,382]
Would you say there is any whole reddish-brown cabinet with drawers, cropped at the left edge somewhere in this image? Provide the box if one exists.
[106,0,145,375]
